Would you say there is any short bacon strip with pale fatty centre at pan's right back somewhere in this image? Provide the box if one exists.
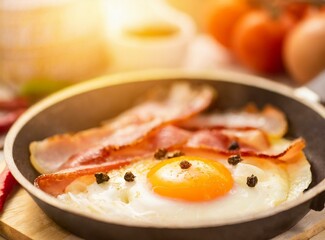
[180,105,288,138]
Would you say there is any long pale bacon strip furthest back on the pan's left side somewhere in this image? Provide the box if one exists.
[30,83,214,173]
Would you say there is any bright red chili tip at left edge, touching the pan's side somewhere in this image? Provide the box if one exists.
[0,167,17,211]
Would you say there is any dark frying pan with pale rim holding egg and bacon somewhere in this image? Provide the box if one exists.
[4,71,325,240]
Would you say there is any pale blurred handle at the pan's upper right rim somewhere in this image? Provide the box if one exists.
[295,70,325,105]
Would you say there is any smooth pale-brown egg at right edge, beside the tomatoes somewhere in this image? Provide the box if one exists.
[283,12,325,83]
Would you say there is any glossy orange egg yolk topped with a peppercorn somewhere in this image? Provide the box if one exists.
[147,156,234,202]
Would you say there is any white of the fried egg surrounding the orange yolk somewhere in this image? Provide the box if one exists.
[58,150,311,226]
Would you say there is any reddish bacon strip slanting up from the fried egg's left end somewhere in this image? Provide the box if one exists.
[34,125,191,196]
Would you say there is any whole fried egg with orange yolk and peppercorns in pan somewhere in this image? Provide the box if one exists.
[58,148,311,227]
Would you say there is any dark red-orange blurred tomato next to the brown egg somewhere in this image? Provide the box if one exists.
[233,9,295,74]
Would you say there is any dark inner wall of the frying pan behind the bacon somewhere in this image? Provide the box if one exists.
[13,79,325,190]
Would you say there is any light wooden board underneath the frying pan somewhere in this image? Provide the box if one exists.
[0,158,325,240]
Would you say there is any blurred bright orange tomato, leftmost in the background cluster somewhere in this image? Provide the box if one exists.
[207,0,251,49]
